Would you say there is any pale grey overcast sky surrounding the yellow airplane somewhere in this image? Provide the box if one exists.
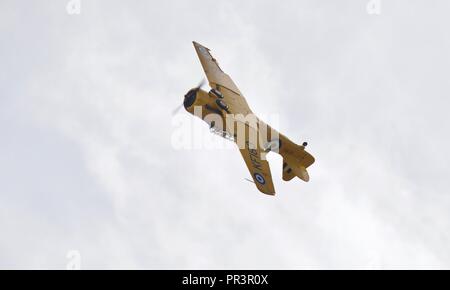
[0,0,450,269]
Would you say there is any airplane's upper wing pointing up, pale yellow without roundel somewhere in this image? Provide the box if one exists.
[193,41,251,115]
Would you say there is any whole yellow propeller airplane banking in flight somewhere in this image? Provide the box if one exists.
[183,41,314,195]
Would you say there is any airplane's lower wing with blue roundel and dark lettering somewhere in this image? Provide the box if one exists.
[238,125,275,195]
